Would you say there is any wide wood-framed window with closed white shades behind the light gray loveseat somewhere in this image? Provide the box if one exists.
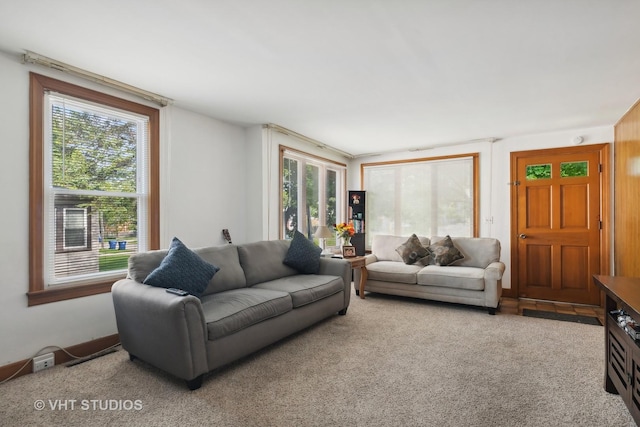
[362,154,479,247]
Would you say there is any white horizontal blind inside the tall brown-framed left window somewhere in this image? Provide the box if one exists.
[44,93,149,286]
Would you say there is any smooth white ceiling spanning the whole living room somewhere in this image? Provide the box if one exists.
[0,0,640,155]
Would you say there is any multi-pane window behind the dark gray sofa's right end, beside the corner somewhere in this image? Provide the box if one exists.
[280,146,347,246]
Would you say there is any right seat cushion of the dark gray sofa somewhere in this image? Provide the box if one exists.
[254,274,344,308]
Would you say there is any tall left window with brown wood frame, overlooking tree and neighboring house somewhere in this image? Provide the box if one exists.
[28,73,159,305]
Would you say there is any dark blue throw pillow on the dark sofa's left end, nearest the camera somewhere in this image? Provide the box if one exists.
[142,237,220,298]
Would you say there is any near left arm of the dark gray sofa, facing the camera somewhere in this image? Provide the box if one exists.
[111,279,208,381]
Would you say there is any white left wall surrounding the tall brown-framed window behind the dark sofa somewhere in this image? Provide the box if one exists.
[0,53,246,366]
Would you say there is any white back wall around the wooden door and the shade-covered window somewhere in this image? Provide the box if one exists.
[348,126,614,288]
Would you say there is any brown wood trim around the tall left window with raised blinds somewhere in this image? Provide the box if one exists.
[27,72,160,306]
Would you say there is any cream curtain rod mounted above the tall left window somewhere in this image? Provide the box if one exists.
[22,50,173,107]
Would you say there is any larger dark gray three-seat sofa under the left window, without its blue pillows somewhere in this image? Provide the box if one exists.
[112,240,351,390]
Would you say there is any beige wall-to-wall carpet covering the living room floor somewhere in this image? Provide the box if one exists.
[0,295,635,426]
